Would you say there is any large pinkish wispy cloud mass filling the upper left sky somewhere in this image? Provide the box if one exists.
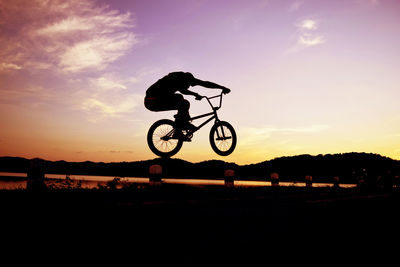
[0,0,141,121]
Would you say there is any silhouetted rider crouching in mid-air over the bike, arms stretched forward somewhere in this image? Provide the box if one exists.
[144,71,231,130]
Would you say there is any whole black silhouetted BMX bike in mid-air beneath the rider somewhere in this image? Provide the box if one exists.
[147,92,237,157]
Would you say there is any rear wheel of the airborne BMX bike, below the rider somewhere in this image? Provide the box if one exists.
[147,119,183,157]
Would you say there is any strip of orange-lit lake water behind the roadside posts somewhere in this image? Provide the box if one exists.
[0,172,355,189]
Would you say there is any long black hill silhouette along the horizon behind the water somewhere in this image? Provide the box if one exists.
[0,152,400,183]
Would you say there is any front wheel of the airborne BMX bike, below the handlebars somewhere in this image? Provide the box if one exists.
[210,121,237,156]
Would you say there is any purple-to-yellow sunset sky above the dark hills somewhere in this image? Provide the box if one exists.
[0,0,400,164]
